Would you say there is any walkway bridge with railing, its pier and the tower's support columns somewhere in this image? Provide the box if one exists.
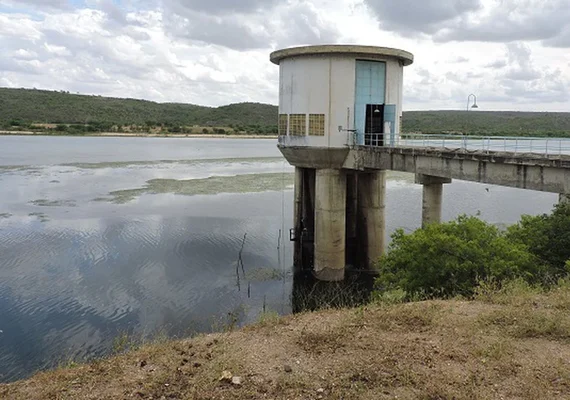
[279,133,570,280]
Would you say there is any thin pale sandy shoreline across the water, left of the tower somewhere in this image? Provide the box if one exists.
[0,131,277,140]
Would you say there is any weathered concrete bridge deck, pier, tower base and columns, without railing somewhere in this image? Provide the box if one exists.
[279,145,570,281]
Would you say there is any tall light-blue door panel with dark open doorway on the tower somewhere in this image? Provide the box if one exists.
[354,60,386,145]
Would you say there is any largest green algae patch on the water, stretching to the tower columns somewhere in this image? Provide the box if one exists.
[103,173,294,204]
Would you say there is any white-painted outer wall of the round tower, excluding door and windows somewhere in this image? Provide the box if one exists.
[279,55,403,147]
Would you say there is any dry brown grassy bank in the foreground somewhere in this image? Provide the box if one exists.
[0,287,570,400]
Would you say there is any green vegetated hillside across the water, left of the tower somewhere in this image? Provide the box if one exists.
[0,88,277,135]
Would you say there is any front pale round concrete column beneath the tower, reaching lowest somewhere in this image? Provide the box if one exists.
[315,169,346,281]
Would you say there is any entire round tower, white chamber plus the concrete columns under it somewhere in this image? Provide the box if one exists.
[270,45,413,281]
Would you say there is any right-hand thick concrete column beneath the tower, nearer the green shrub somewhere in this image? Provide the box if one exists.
[358,171,386,270]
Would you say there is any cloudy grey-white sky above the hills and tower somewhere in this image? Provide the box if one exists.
[0,0,570,111]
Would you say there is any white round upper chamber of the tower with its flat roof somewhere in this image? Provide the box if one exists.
[270,45,413,147]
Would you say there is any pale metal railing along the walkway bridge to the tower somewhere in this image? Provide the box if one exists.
[365,133,570,156]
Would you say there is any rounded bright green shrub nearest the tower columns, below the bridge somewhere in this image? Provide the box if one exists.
[376,216,543,298]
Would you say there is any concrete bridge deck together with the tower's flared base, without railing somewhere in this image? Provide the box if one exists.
[279,141,570,193]
